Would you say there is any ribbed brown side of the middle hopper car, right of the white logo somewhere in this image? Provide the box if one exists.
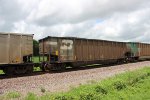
[75,39,127,61]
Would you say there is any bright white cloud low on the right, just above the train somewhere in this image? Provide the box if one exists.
[83,8,150,42]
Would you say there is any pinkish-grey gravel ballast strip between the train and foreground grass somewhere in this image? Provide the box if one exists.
[0,61,150,95]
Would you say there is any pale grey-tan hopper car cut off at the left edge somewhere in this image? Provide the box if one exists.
[0,33,33,75]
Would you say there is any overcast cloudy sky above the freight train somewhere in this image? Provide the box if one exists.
[0,0,150,43]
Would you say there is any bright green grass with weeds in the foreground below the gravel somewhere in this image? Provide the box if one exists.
[2,67,150,100]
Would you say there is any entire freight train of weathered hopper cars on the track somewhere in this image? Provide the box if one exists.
[0,33,150,75]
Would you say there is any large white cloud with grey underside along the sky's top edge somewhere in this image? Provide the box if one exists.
[25,0,148,26]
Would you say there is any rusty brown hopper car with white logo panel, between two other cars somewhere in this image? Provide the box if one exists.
[39,36,138,70]
